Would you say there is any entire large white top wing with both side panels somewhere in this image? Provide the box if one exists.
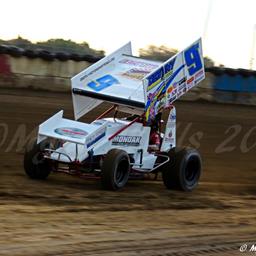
[71,39,205,121]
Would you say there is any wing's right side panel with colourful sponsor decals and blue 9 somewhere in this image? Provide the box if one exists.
[143,39,205,121]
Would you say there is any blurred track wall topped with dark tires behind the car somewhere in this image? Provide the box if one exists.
[0,46,256,105]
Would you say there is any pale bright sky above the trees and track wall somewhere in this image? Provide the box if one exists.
[0,0,256,69]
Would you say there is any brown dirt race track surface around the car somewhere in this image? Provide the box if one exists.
[0,90,256,256]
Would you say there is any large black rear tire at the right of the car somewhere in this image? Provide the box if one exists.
[162,148,202,191]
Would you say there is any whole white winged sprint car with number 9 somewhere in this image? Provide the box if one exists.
[24,39,205,191]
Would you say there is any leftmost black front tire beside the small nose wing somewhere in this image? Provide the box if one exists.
[24,141,52,180]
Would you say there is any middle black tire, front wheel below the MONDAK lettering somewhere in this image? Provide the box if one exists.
[101,149,130,190]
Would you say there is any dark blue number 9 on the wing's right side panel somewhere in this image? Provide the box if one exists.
[184,43,203,76]
